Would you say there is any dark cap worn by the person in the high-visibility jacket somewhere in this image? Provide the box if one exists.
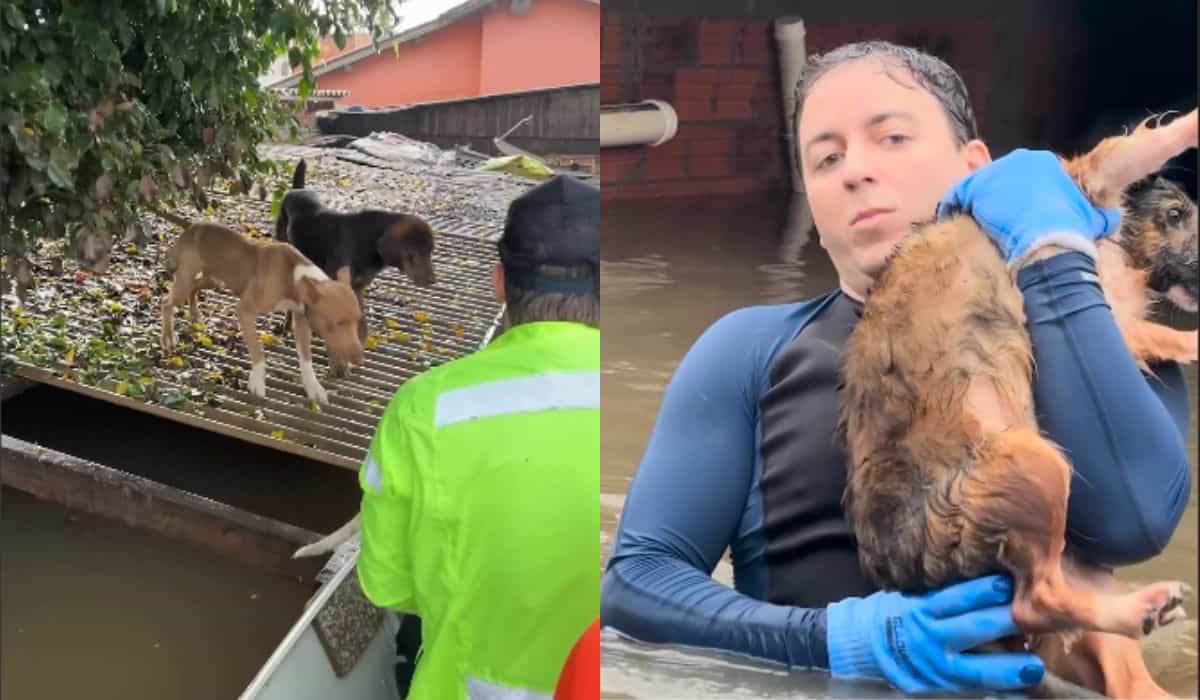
[499,175,600,298]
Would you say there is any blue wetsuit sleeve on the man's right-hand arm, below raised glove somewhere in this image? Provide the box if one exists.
[1018,252,1192,567]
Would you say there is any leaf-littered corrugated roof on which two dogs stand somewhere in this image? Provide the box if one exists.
[0,148,529,468]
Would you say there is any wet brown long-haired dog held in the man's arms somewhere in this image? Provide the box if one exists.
[841,112,1196,696]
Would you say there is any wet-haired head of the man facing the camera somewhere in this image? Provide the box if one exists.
[792,41,990,299]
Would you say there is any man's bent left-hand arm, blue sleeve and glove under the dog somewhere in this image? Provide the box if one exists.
[600,306,1044,692]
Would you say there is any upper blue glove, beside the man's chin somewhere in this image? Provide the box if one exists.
[937,149,1121,269]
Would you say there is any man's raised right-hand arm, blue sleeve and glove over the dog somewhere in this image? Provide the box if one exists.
[940,149,1190,566]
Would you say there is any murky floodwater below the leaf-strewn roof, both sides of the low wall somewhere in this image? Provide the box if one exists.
[0,387,358,700]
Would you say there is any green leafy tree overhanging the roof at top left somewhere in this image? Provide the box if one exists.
[0,0,398,279]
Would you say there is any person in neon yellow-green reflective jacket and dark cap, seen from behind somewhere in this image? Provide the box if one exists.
[358,177,600,700]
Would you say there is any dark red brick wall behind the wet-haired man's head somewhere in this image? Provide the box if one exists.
[600,11,1086,201]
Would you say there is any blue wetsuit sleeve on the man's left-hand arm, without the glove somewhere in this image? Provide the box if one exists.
[600,307,828,668]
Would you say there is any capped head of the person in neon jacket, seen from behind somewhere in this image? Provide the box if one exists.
[492,175,600,328]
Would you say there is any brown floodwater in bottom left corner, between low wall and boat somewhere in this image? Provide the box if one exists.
[0,489,312,700]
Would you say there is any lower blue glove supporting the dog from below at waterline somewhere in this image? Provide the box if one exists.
[826,576,1045,693]
